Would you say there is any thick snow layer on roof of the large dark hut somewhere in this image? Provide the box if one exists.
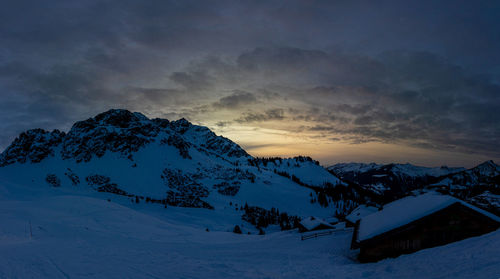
[358,192,500,241]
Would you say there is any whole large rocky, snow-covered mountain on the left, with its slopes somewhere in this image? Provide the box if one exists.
[0,109,360,232]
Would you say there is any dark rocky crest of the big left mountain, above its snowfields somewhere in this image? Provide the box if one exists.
[0,109,249,166]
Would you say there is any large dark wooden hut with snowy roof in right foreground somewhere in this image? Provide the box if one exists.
[351,193,500,262]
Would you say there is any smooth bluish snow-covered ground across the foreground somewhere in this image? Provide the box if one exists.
[0,185,500,278]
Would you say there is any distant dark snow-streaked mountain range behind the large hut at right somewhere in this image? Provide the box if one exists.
[327,161,500,215]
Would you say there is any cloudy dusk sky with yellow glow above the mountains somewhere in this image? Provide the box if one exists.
[0,0,500,167]
